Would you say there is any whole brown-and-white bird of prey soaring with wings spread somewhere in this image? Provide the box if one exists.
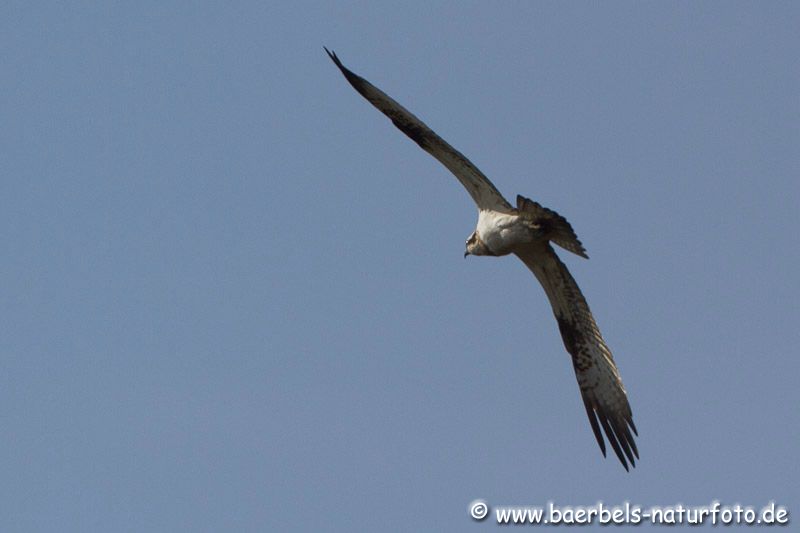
[325,48,639,470]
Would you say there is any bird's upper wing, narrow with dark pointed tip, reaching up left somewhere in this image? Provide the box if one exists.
[325,48,513,213]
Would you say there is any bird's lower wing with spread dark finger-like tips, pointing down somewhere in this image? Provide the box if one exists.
[516,244,639,470]
